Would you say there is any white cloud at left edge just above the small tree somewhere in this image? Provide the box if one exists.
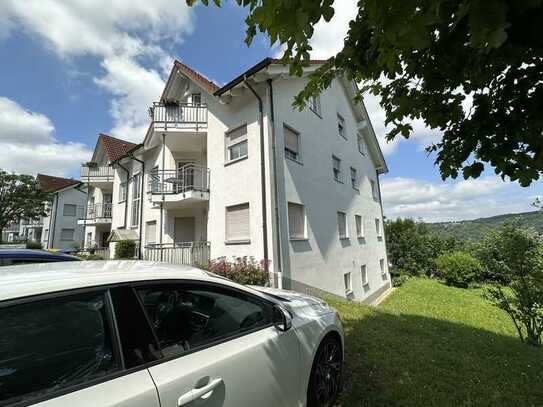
[0,97,92,176]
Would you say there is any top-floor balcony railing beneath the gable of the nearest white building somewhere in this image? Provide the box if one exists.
[149,102,207,129]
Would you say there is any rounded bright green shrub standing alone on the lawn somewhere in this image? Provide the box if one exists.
[436,252,483,288]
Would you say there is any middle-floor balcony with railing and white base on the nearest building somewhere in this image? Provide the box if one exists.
[147,164,209,207]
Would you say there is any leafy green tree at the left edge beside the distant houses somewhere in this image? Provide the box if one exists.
[0,169,49,243]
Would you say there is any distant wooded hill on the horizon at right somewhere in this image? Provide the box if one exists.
[427,211,543,240]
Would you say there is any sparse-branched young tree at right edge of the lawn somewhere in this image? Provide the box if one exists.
[484,224,543,346]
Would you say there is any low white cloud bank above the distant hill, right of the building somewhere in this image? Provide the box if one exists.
[381,176,539,222]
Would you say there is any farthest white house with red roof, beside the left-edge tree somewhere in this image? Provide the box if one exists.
[37,174,87,249]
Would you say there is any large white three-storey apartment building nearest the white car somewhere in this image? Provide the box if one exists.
[82,58,391,302]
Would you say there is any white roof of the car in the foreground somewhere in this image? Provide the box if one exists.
[0,260,216,301]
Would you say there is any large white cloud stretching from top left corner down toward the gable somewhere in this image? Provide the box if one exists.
[0,0,193,140]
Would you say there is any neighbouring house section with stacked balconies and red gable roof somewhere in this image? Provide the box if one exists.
[78,134,136,249]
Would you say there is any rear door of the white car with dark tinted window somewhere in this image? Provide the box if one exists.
[0,289,159,407]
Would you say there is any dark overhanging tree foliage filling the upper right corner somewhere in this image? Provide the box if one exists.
[187,0,543,186]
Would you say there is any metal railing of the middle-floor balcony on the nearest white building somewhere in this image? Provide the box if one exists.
[147,164,209,194]
